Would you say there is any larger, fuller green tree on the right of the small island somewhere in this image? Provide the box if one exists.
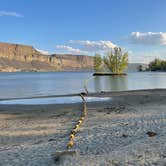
[104,47,128,74]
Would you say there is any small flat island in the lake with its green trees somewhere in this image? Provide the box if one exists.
[93,47,128,76]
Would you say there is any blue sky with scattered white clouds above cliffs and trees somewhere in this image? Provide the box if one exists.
[0,0,166,63]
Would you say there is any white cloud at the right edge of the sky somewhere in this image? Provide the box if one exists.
[128,32,166,45]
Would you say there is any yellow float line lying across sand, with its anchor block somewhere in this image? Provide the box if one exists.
[55,93,87,162]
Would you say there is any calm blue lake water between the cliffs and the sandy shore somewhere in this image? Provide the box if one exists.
[0,72,166,99]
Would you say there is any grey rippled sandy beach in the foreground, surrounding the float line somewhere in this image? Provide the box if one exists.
[0,89,166,166]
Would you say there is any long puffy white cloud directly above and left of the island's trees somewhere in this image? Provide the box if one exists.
[70,40,117,52]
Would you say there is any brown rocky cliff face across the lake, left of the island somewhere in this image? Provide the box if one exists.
[0,43,93,71]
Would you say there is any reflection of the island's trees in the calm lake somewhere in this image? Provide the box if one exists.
[94,76,128,92]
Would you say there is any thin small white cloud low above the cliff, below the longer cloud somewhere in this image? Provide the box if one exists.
[56,45,88,54]
